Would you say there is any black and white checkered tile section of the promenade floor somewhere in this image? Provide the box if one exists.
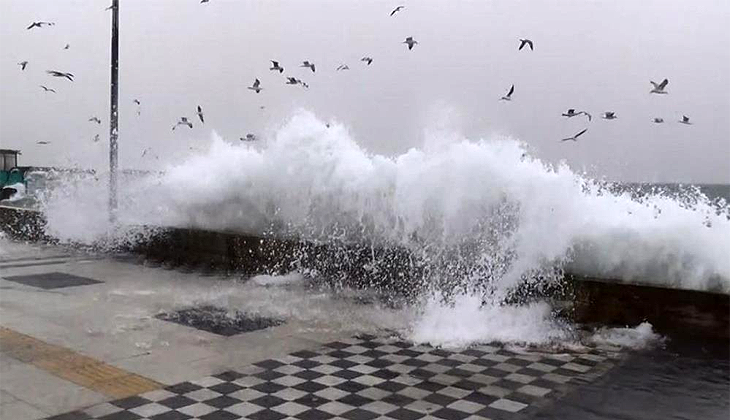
[45,336,617,420]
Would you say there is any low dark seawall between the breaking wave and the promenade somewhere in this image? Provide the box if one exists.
[0,206,730,339]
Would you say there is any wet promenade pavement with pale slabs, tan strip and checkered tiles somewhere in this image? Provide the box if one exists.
[0,242,728,420]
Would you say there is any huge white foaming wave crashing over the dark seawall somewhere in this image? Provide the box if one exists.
[38,112,730,293]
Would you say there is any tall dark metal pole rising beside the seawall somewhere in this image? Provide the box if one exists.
[109,0,119,222]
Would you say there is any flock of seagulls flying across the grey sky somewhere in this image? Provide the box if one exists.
[18,0,692,152]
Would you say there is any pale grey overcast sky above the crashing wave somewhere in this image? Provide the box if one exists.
[0,0,730,183]
